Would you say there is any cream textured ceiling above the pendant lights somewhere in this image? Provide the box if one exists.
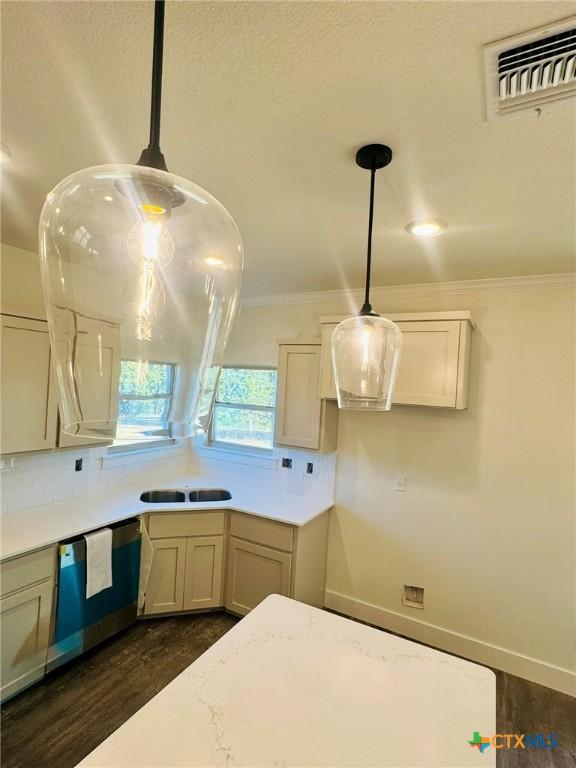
[1,0,576,295]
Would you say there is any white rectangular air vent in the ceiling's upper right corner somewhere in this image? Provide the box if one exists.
[484,17,576,119]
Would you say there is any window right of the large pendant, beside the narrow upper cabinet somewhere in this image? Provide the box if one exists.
[210,368,276,450]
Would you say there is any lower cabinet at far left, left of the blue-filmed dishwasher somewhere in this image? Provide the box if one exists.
[0,548,56,700]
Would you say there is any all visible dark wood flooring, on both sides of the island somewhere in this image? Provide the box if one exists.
[0,613,576,768]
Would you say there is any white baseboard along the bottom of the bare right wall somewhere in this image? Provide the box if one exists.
[324,590,576,696]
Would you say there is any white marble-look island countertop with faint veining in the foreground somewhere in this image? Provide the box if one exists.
[79,595,496,768]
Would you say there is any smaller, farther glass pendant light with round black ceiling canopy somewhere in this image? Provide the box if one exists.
[332,144,402,411]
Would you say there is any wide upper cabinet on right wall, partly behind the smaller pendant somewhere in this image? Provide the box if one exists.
[320,312,472,409]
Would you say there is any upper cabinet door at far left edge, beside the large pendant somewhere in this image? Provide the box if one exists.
[0,315,57,453]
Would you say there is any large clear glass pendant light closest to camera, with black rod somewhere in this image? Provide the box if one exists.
[39,0,244,438]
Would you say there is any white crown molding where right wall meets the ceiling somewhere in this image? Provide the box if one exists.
[241,272,576,307]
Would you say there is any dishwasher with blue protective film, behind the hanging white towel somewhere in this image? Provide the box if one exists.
[47,518,141,671]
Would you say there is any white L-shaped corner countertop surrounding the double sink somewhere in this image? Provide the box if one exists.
[0,475,333,560]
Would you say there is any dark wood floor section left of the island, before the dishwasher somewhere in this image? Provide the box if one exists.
[0,613,237,768]
